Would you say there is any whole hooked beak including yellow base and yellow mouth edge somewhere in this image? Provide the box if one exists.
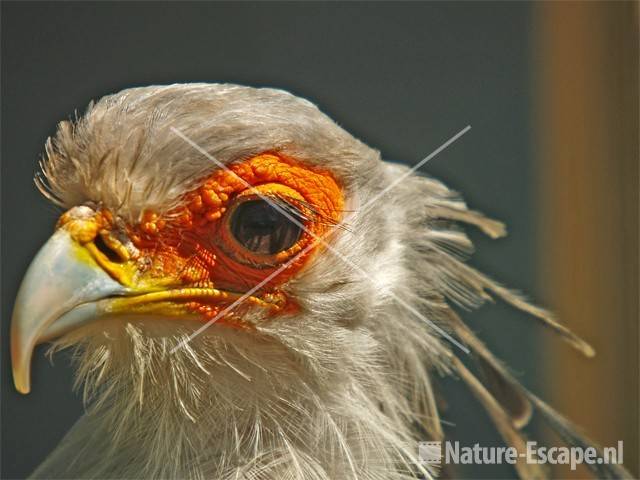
[11,206,283,393]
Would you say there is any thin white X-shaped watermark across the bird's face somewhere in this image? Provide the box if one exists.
[170,126,471,354]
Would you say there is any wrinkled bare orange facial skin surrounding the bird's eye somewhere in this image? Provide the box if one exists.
[119,153,344,323]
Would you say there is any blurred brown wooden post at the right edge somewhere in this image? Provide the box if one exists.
[534,1,640,478]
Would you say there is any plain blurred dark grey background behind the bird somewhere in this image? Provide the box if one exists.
[1,2,636,478]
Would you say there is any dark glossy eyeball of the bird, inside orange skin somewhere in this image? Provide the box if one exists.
[231,200,302,255]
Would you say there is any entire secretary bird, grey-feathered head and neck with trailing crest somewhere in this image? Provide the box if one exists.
[11,84,632,480]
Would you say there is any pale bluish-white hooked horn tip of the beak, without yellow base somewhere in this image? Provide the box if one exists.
[11,228,128,393]
